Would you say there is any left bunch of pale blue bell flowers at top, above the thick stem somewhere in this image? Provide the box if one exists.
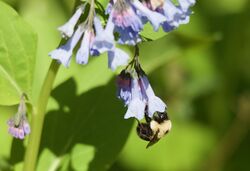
[49,1,129,70]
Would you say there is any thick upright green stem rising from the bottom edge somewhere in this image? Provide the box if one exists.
[23,60,60,171]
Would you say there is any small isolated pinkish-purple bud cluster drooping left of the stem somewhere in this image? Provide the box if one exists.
[7,95,30,139]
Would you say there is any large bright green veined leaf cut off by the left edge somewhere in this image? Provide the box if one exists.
[0,2,37,105]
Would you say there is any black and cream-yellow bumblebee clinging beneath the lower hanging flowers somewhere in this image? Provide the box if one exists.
[136,112,172,148]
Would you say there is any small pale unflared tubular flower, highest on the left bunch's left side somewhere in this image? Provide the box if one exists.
[58,5,85,38]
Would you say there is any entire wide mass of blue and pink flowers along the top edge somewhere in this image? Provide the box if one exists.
[49,0,195,70]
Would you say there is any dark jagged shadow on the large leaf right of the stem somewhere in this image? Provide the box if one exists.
[40,79,133,171]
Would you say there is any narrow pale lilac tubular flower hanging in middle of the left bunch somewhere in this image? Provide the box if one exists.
[76,28,94,64]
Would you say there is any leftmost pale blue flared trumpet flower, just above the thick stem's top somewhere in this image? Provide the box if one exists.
[49,26,84,67]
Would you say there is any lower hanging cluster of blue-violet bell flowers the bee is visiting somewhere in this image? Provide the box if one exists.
[117,48,167,120]
